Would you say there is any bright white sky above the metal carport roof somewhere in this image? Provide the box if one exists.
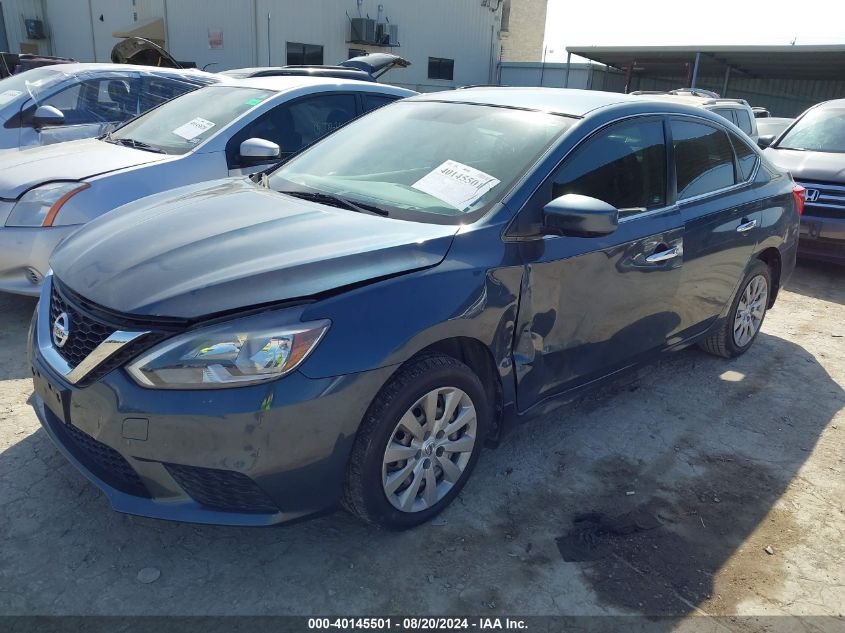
[546,0,845,62]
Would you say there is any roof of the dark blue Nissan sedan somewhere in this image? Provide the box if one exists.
[410,86,641,117]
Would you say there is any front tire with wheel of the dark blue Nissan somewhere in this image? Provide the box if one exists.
[343,354,491,530]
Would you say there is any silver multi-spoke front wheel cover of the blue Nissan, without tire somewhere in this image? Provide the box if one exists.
[382,387,478,512]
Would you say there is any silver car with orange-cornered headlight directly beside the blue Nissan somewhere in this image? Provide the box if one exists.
[0,77,416,295]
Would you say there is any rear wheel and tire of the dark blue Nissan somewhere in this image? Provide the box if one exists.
[699,260,772,358]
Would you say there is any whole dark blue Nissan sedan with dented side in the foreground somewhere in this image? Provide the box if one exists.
[30,88,803,528]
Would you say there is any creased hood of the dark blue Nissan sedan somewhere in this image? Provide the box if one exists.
[50,179,459,319]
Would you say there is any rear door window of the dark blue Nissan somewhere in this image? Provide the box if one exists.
[671,120,735,200]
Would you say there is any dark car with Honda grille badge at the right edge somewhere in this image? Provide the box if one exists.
[765,99,845,264]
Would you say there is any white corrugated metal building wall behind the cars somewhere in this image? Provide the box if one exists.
[0,0,502,91]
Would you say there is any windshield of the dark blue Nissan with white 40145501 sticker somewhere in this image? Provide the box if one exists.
[269,101,572,223]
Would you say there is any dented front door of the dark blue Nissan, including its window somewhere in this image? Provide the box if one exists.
[514,117,684,411]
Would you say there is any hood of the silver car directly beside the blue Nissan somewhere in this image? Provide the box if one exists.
[0,139,172,199]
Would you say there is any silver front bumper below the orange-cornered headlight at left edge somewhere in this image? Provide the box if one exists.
[0,225,79,297]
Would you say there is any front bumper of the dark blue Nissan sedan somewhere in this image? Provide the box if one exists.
[30,308,392,526]
